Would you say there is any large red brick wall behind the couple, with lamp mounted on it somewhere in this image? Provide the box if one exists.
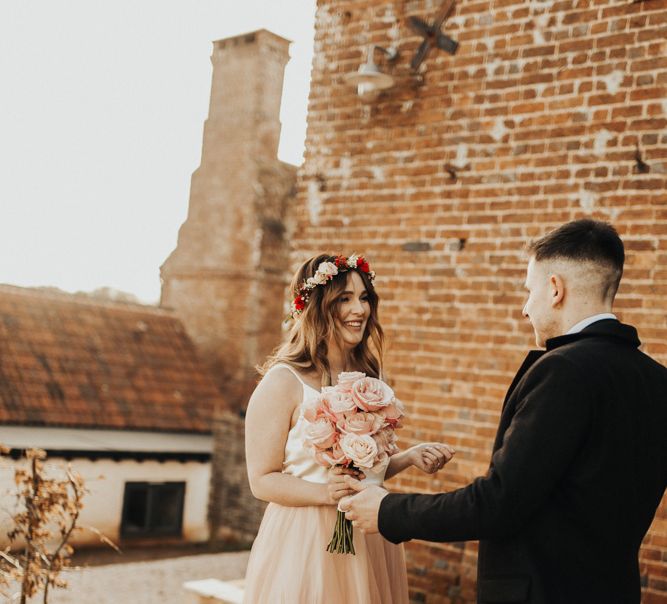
[293,0,667,603]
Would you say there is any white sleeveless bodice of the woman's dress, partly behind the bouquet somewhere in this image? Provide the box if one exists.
[271,363,389,485]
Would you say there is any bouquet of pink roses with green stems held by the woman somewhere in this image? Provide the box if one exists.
[304,371,403,554]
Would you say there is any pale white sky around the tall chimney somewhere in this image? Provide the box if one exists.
[0,0,315,302]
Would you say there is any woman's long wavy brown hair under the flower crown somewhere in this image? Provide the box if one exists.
[258,254,384,386]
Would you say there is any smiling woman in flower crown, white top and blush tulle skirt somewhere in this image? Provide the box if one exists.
[244,255,454,604]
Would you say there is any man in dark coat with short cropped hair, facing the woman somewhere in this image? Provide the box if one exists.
[341,220,667,604]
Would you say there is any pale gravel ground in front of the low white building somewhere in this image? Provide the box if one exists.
[49,551,249,604]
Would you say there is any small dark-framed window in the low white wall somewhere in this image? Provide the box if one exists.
[120,482,185,537]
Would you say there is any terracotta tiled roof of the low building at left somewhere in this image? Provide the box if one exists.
[0,285,220,432]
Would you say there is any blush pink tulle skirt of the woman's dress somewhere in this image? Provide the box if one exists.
[244,503,408,604]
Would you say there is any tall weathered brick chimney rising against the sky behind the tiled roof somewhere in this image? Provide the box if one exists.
[160,30,296,410]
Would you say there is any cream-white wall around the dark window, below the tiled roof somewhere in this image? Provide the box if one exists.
[0,457,211,548]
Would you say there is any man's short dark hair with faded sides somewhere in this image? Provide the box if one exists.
[528,218,625,301]
